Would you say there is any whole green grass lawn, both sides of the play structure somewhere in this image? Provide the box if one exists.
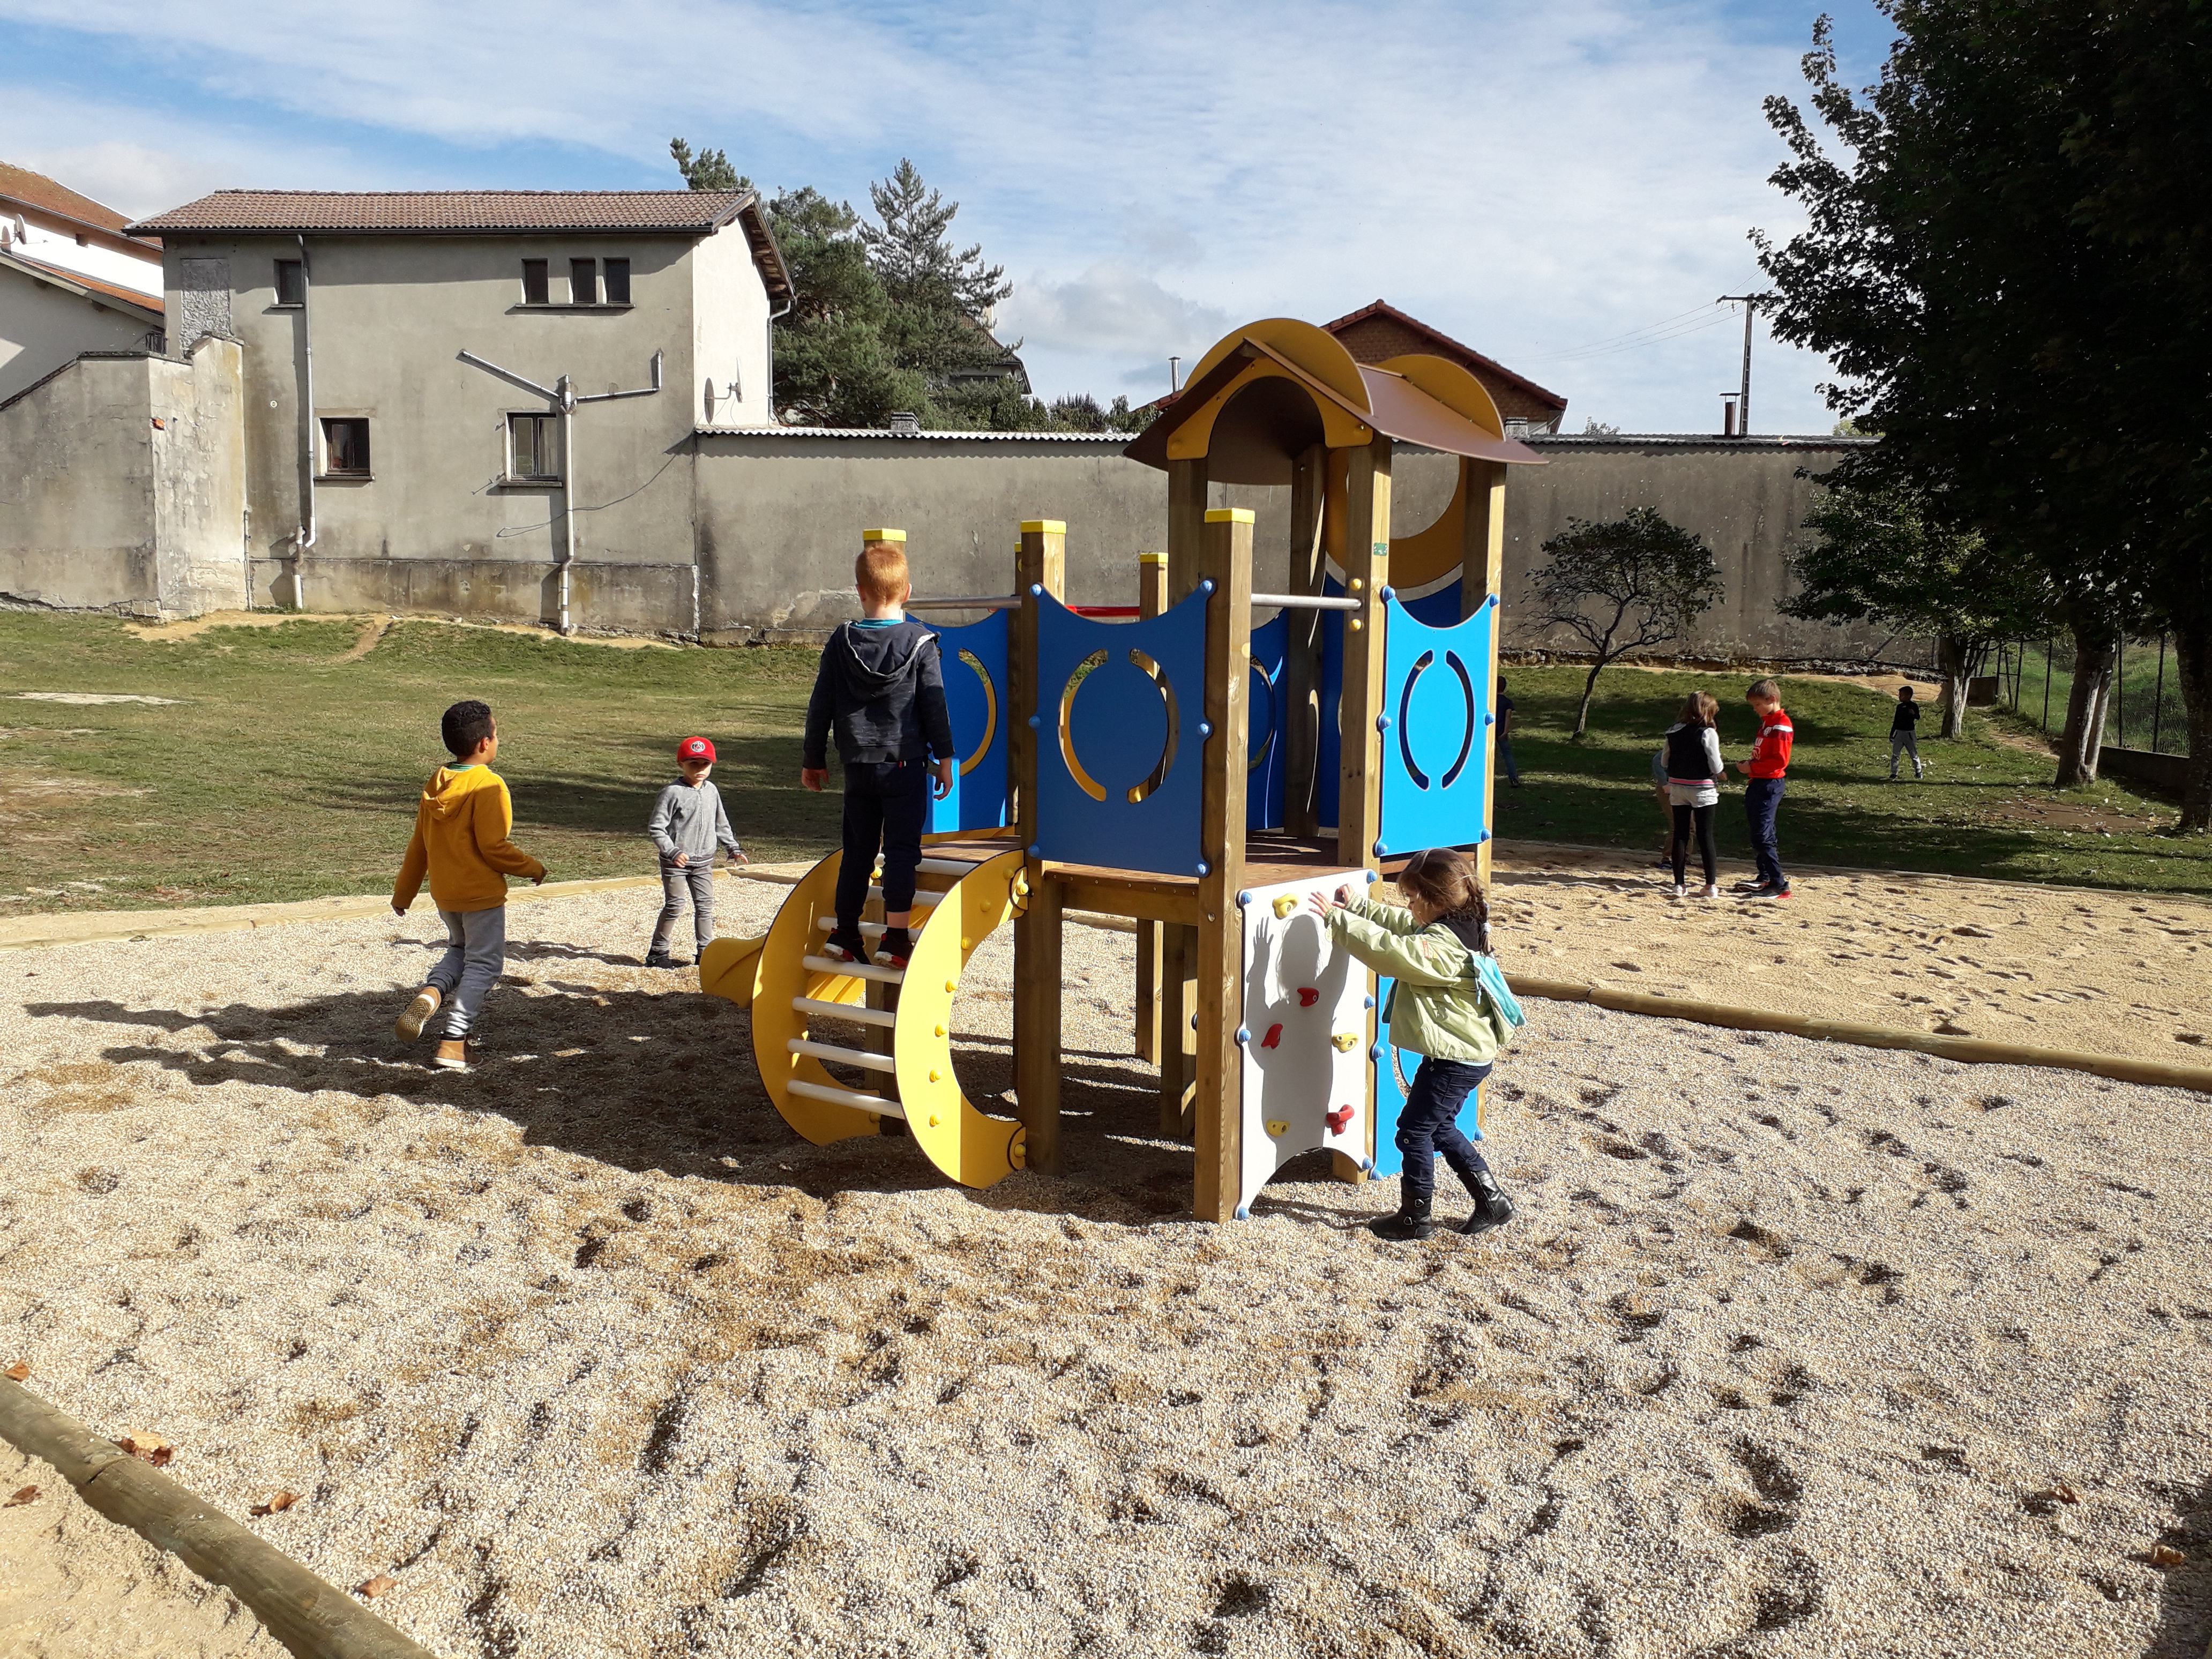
[0,612,2212,916]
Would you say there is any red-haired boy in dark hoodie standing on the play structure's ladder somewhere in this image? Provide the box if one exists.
[798,531,953,967]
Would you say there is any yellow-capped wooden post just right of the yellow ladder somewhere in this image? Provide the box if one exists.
[1006,518,1068,1175]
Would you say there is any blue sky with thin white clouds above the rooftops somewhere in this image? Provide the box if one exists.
[0,0,1891,434]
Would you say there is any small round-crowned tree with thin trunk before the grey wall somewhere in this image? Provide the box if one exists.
[1528,506,1721,737]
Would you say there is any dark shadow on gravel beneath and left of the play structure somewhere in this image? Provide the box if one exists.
[24,982,1230,1223]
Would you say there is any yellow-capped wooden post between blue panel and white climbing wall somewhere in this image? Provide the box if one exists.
[1170,506,1252,1221]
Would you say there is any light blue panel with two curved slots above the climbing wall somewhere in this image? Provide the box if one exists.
[1373,588,1498,856]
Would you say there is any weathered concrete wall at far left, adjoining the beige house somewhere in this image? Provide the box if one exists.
[0,339,243,615]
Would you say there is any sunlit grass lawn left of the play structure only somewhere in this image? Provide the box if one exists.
[0,612,839,914]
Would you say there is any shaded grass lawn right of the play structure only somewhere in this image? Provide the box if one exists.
[1498,666,2212,894]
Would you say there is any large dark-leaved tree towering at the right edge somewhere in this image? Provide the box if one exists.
[1754,0,2212,829]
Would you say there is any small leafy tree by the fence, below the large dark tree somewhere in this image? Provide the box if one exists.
[1783,484,2051,737]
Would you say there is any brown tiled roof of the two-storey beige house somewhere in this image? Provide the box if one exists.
[131,190,754,237]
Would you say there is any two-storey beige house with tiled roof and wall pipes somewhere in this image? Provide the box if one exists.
[131,190,790,622]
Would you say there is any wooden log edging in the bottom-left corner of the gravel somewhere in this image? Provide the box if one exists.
[0,1378,436,1659]
